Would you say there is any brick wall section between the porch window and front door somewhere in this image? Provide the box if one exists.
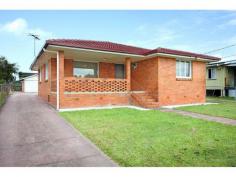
[99,62,115,78]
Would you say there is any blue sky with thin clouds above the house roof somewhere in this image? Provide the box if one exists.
[0,10,236,71]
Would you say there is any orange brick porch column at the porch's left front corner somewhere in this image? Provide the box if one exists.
[59,51,65,109]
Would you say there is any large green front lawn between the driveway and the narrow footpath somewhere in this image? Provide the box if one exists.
[60,108,236,166]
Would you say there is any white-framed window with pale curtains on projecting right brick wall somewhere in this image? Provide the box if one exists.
[176,60,192,78]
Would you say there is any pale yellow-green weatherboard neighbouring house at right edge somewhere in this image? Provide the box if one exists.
[206,60,236,97]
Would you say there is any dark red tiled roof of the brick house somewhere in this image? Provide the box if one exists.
[46,39,220,61]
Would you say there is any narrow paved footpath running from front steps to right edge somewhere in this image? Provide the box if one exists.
[160,109,236,126]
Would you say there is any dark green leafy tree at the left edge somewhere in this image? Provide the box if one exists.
[0,56,18,83]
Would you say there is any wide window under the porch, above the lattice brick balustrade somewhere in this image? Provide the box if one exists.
[73,61,98,78]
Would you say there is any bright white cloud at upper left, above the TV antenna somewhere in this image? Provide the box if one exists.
[0,18,53,39]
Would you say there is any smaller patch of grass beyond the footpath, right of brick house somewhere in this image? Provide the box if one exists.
[177,97,236,119]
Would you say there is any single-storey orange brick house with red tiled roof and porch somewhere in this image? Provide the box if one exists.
[31,39,220,110]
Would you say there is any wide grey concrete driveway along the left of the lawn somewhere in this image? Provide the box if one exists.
[0,93,117,166]
